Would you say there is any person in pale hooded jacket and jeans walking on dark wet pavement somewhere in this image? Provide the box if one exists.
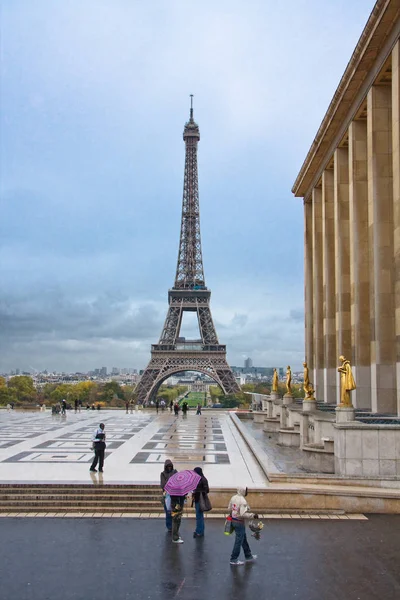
[228,488,258,566]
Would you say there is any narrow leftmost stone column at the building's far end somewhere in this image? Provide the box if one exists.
[304,200,314,372]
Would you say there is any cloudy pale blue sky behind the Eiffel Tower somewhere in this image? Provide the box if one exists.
[0,0,374,372]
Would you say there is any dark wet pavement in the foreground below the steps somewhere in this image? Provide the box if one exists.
[0,515,400,600]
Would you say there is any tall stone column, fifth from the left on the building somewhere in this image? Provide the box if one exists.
[349,120,371,408]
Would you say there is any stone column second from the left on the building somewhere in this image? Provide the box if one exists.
[312,188,325,400]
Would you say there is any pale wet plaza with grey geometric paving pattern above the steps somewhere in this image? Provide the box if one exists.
[0,410,267,488]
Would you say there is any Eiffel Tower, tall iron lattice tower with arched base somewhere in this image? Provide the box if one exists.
[135,95,240,404]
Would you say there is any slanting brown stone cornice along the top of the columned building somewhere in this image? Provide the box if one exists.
[292,0,400,202]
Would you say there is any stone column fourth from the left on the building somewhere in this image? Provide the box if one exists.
[334,148,351,404]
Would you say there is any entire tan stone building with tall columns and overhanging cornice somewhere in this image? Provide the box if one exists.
[292,0,400,415]
